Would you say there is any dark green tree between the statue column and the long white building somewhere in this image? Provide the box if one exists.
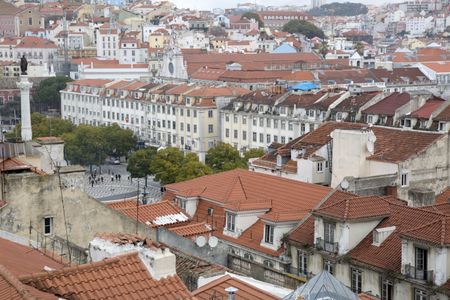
[31,76,72,112]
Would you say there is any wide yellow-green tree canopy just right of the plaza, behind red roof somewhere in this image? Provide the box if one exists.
[150,147,212,185]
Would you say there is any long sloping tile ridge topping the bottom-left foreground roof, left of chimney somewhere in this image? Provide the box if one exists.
[19,251,138,282]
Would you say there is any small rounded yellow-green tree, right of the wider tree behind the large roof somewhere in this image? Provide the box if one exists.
[206,142,246,172]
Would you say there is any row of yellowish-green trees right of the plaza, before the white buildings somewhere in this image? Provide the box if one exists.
[127,142,264,185]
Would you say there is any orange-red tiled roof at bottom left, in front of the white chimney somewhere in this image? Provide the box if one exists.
[19,252,193,300]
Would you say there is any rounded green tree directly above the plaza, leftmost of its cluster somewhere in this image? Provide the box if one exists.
[63,125,107,169]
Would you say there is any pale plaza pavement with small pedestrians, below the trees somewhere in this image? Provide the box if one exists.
[85,164,161,203]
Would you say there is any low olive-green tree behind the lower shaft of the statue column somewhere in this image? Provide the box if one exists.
[7,113,75,139]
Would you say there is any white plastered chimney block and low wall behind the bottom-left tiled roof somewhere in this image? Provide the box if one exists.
[89,234,176,280]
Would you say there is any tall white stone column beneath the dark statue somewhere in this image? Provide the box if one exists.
[17,75,33,142]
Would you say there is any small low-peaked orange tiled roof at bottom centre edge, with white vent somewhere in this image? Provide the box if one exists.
[193,275,279,300]
